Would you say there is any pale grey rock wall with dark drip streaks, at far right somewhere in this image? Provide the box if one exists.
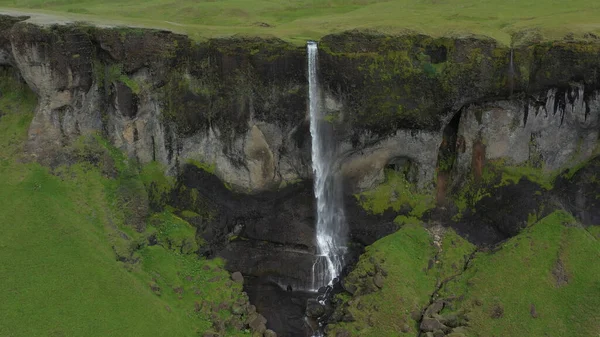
[456,85,600,184]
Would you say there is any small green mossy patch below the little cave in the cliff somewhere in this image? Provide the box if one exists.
[355,170,435,218]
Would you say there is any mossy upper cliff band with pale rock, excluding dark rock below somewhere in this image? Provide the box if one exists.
[0,17,600,192]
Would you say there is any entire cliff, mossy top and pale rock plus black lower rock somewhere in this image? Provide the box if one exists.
[0,16,600,335]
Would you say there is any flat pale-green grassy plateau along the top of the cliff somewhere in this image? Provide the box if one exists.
[0,0,600,44]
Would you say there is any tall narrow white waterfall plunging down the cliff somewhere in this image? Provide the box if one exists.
[307,41,346,291]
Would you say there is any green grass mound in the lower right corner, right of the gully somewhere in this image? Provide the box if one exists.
[444,212,600,337]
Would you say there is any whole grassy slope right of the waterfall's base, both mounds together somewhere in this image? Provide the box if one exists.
[329,212,600,337]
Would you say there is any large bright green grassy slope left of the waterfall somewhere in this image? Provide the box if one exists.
[0,72,250,337]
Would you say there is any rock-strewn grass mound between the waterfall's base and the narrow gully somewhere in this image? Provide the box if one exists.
[330,223,474,337]
